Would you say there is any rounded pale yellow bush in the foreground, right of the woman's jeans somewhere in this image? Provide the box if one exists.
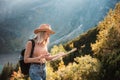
[48,55,101,80]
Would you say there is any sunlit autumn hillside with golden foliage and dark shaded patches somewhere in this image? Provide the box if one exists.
[0,2,120,80]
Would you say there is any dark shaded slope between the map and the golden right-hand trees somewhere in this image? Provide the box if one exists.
[63,27,99,64]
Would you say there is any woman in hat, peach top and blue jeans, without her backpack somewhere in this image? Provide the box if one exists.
[24,24,64,80]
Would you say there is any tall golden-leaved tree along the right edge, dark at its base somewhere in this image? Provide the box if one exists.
[91,3,120,80]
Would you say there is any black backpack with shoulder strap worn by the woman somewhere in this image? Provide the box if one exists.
[19,39,35,75]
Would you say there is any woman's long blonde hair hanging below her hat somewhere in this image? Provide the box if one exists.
[35,31,49,45]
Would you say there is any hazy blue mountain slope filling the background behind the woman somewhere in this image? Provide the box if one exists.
[0,0,119,53]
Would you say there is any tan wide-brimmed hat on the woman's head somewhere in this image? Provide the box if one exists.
[34,24,55,34]
